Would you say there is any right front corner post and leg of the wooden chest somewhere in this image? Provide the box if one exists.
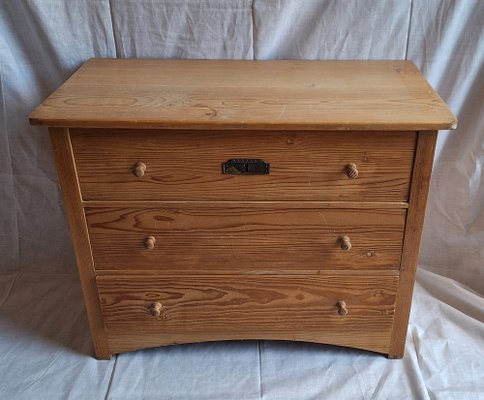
[388,131,437,358]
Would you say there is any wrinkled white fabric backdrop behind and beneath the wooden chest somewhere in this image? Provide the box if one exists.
[0,0,484,399]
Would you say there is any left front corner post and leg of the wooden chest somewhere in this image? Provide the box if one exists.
[49,128,111,360]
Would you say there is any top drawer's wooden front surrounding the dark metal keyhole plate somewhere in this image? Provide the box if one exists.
[71,129,416,202]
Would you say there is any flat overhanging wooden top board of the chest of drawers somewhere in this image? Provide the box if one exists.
[30,59,457,130]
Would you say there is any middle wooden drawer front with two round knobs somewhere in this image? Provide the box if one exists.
[85,206,406,274]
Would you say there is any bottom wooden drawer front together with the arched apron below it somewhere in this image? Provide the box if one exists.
[97,274,398,353]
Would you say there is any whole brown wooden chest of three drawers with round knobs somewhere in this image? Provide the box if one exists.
[30,59,456,358]
